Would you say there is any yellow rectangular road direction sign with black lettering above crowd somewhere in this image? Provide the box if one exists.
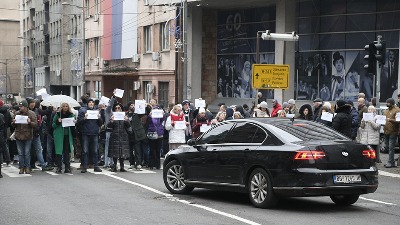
[252,64,290,89]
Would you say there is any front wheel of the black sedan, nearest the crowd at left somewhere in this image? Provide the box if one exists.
[163,160,194,194]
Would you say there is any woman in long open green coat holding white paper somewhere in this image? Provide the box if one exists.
[52,103,76,173]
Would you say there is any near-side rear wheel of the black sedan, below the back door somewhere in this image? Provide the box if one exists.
[248,168,278,208]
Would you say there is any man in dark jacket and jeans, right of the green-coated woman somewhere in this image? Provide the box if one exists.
[78,99,103,173]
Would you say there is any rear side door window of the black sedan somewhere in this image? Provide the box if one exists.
[225,123,267,143]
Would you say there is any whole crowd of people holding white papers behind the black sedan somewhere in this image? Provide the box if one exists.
[0,93,400,177]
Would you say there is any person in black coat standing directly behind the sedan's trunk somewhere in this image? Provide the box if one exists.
[332,99,352,138]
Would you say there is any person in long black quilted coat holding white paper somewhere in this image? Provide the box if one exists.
[107,103,132,172]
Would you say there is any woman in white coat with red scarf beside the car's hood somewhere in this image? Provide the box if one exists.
[165,105,189,150]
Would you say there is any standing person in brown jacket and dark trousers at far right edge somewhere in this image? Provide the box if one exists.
[383,98,400,168]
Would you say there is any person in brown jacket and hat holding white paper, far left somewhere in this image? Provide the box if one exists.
[11,100,38,174]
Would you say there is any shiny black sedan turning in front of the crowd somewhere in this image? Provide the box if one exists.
[163,118,378,208]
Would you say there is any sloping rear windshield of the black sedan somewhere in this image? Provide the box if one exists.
[273,120,348,141]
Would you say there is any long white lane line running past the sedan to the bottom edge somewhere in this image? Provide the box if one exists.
[104,174,260,225]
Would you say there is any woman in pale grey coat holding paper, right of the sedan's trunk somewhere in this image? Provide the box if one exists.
[357,105,381,162]
